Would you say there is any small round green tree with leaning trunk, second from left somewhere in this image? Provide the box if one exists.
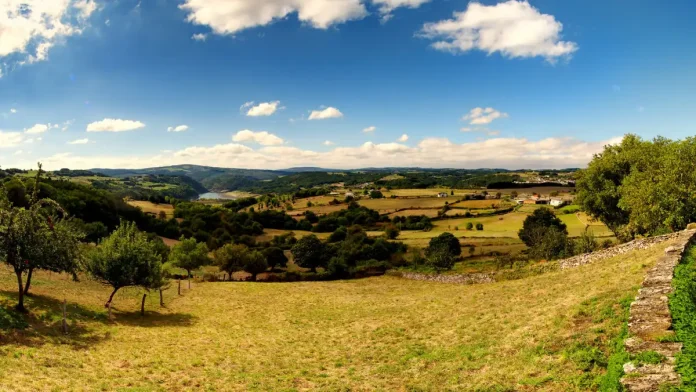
[87,222,164,308]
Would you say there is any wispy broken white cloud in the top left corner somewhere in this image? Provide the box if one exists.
[0,0,96,64]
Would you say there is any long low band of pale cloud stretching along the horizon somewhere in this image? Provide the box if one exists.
[9,135,621,170]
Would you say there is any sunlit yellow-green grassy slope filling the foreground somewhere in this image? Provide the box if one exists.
[0,244,668,391]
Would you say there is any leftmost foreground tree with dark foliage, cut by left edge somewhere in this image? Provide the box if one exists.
[0,164,84,311]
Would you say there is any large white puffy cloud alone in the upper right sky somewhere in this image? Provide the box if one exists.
[420,0,578,62]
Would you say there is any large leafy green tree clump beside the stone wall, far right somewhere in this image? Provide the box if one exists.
[577,135,696,239]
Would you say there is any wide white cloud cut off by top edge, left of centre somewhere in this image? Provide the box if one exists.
[179,0,367,35]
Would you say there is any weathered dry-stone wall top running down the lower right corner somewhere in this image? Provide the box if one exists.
[621,230,696,392]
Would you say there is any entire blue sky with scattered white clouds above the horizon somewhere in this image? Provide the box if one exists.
[0,0,696,169]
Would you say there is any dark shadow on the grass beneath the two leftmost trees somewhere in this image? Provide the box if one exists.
[0,290,196,350]
